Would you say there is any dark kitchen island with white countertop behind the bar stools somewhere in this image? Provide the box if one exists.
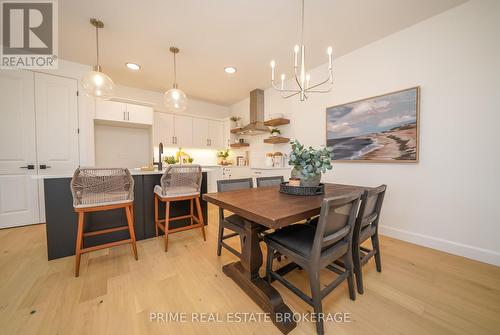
[43,169,208,260]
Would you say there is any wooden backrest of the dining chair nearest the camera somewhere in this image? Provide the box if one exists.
[311,192,362,259]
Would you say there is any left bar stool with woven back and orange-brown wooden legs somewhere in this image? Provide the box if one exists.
[71,168,138,277]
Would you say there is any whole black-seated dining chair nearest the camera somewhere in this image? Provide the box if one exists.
[264,192,361,334]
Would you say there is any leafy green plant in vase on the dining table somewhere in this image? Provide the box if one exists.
[288,140,333,186]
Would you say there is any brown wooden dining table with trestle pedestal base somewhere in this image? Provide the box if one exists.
[203,184,368,334]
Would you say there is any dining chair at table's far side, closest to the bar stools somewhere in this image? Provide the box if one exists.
[217,178,253,257]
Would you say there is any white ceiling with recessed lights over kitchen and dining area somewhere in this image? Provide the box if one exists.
[59,0,465,105]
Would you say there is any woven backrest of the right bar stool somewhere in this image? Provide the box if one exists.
[160,164,203,194]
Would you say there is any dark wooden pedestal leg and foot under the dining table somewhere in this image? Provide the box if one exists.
[222,220,297,334]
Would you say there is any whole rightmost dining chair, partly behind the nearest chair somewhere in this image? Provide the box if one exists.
[352,185,387,294]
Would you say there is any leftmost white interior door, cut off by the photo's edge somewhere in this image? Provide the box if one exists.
[0,70,40,228]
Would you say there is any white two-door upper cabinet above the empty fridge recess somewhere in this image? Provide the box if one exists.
[95,100,153,125]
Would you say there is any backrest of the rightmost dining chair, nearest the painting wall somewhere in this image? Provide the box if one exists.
[355,185,387,238]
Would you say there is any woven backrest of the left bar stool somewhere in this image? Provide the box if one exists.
[71,167,134,208]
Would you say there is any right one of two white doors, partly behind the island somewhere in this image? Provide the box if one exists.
[35,73,79,175]
